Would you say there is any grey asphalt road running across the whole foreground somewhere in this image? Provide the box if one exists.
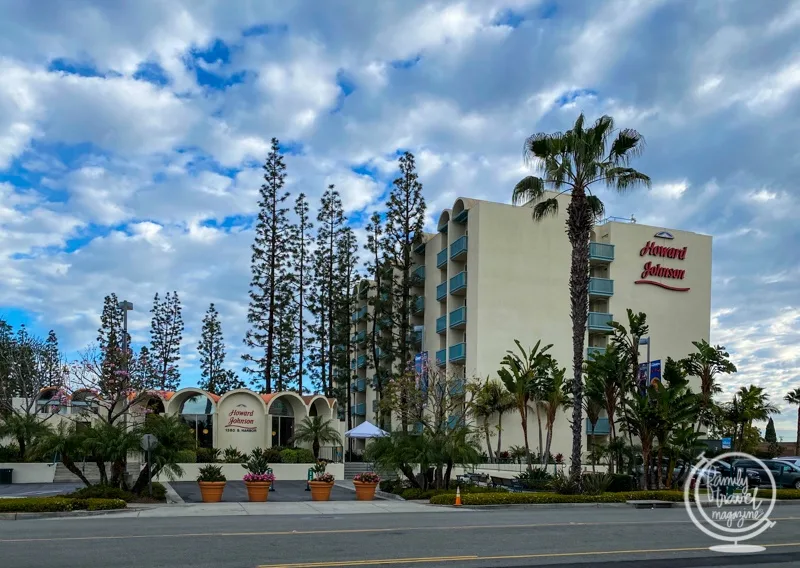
[0,506,800,568]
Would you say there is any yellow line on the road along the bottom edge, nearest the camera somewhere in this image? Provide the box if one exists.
[258,542,800,568]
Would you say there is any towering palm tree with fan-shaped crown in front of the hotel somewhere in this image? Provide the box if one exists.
[512,113,650,479]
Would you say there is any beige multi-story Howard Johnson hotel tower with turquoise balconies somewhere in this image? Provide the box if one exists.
[351,193,711,455]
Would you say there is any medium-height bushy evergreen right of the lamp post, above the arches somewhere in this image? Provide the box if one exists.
[150,292,183,391]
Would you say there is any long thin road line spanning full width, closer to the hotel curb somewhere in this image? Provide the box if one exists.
[0,517,800,543]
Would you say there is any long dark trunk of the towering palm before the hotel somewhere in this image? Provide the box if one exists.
[567,193,593,481]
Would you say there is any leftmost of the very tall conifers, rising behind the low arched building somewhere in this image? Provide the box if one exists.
[243,138,289,393]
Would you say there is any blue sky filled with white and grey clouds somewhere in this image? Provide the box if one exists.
[0,0,800,440]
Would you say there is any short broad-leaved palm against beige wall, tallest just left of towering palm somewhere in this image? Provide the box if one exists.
[497,339,552,466]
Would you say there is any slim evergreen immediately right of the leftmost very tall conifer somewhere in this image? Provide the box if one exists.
[292,193,313,394]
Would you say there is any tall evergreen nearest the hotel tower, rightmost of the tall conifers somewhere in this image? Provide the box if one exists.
[382,152,425,432]
